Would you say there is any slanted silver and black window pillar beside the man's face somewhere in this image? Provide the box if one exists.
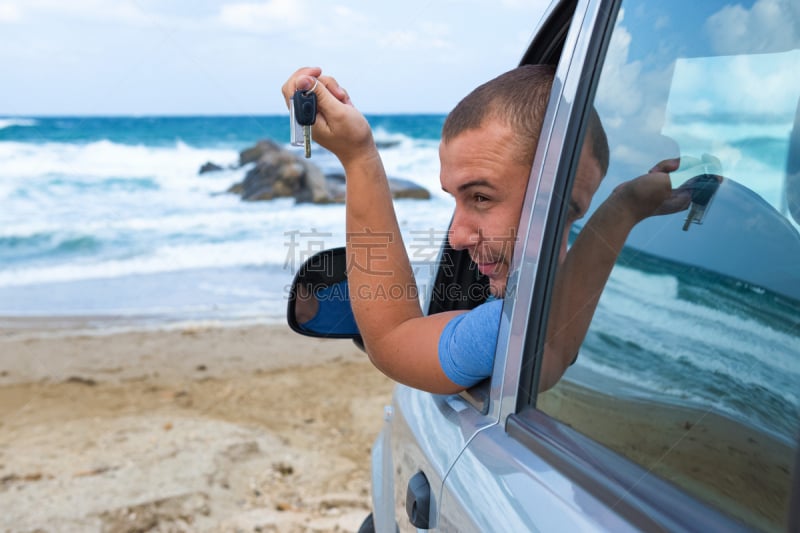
[492,0,621,420]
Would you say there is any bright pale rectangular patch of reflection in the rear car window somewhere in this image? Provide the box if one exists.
[663,50,800,209]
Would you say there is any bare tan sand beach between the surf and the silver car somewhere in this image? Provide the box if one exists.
[0,318,392,532]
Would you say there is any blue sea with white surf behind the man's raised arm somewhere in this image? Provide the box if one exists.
[0,114,453,326]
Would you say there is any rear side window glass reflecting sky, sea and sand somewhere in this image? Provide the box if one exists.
[536,0,800,529]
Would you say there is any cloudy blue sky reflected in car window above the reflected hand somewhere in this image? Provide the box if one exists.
[595,0,800,216]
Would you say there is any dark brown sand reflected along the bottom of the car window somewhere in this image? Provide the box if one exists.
[537,380,794,531]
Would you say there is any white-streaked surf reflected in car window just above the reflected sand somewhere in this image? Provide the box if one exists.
[586,268,800,412]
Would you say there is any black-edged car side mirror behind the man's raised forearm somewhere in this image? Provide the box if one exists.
[286,248,363,342]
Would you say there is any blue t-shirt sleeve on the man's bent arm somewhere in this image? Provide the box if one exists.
[439,299,503,387]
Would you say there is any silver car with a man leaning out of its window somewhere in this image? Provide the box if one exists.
[289,0,800,532]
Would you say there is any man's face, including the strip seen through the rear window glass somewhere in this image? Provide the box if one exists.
[439,121,603,298]
